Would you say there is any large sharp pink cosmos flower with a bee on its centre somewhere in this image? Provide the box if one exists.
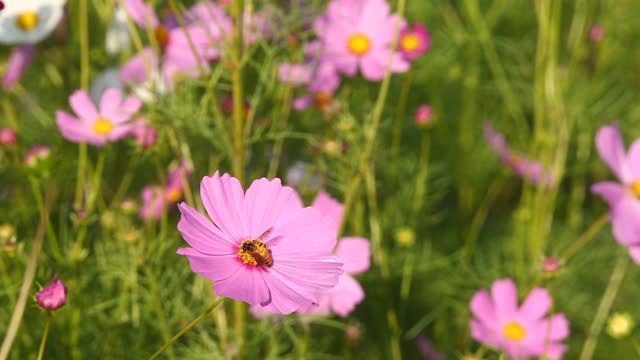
[178,172,342,314]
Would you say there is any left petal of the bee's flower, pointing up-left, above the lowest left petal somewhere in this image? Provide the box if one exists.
[178,203,238,255]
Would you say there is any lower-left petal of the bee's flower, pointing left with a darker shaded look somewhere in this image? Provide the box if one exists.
[177,248,243,281]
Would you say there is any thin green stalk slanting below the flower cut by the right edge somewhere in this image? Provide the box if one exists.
[580,251,629,360]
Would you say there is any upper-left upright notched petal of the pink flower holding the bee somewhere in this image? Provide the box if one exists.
[200,171,250,243]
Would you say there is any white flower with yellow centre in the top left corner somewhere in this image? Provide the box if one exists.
[0,0,66,45]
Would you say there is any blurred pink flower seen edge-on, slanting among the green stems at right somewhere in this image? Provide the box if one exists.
[484,123,555,188]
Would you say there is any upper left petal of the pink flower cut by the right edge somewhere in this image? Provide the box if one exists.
[596,126,632,184]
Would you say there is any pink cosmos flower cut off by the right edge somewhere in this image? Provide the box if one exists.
[591,125,640,264]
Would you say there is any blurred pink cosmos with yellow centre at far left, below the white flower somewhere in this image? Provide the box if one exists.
[56,89,142,146]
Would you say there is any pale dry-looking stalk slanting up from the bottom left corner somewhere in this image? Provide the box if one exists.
[0,190,50,360]
